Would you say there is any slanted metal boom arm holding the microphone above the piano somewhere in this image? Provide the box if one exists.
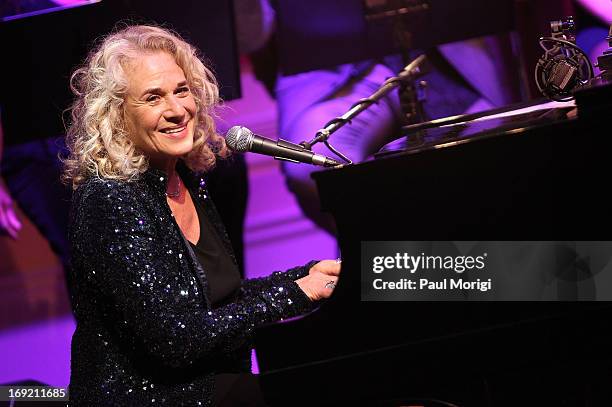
[300,55,426,164]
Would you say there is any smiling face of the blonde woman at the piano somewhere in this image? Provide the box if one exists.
[125,51,196,169]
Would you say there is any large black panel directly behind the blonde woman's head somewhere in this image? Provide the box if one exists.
[0,0,240,144]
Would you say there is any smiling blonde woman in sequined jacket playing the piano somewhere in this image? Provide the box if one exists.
[65,26,340,406]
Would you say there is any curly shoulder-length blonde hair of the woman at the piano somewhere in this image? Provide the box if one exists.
[63,25,228,188]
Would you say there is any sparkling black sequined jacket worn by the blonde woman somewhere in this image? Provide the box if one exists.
[69,164,313,407]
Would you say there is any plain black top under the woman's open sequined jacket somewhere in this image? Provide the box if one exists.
[189,192,240,309]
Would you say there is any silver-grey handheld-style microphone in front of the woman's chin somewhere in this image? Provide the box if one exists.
[225,126,342,167]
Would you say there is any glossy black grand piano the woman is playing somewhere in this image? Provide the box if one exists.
[256,85,612,406]
